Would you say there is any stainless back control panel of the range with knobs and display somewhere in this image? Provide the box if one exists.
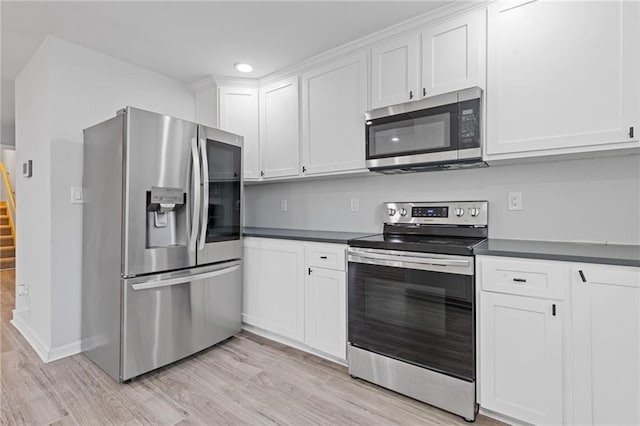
[382,201,489,226]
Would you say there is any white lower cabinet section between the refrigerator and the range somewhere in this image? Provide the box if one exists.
[242,237,347,362]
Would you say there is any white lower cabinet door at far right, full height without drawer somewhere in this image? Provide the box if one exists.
[572,265,640,425]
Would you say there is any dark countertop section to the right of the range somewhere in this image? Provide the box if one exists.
[473,238,640,266]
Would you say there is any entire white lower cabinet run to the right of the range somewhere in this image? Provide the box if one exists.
[476,256,640,426]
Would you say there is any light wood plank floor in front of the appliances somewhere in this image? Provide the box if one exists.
[0,271,498,425]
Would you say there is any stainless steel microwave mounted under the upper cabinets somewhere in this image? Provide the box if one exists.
[365,87,486,173]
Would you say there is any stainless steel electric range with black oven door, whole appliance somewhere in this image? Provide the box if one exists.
[348,201,488,421]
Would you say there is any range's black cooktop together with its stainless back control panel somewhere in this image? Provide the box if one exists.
[349,201,488,255]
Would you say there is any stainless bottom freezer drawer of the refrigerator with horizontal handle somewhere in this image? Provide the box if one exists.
[121,260,242,381]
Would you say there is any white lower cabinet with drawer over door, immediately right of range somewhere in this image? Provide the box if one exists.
[476,256,569,425]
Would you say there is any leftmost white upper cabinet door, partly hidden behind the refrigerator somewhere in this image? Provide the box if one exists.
[218,87,260,180]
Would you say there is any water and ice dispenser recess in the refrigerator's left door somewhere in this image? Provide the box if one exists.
[146,186,187,248]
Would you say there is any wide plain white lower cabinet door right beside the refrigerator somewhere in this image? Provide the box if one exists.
[242,239,304,342]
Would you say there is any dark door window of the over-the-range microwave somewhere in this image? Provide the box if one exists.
[367,104,458,159]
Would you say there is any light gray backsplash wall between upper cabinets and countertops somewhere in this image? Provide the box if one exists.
[245,154,640,244]
